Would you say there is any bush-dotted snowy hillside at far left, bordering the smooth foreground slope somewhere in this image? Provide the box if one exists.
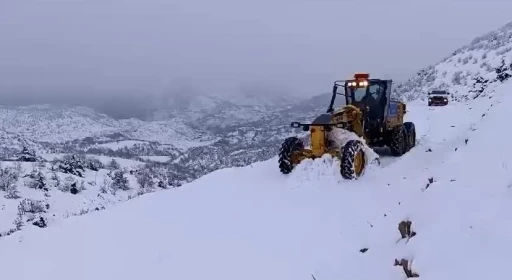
[0,154,181,237]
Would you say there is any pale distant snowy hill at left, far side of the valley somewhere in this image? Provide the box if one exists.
[0,105,214,148]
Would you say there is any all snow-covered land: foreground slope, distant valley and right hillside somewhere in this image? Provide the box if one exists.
[0,18,512,280]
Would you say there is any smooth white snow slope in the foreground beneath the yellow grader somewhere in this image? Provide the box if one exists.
[0,78,512,280]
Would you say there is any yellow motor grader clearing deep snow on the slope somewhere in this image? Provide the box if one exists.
[279,73,416,180]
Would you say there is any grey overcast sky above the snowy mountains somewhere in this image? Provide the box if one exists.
[0,0,512,106]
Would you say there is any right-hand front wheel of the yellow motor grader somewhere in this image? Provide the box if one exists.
[340,140,366,180]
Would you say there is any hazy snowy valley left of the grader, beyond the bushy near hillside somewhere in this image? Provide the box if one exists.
[0,92,328,181]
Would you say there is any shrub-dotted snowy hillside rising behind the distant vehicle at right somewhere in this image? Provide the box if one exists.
[395,22,512,100]
